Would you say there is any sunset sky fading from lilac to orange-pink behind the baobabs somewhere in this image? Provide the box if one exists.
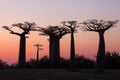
[0,0,120,64]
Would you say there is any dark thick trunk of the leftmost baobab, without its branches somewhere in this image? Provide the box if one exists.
[18,35,26,68]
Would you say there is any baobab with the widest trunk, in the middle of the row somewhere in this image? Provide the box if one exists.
[40,26,70,67]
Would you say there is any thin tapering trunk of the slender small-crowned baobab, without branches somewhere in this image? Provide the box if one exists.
[70,32,75,67]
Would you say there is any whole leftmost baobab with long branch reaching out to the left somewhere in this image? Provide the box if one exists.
[3,22,36,68]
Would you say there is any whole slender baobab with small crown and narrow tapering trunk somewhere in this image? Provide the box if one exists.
[62,21,79,67]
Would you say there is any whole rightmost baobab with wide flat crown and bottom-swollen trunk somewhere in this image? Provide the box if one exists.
[82,19,118,71]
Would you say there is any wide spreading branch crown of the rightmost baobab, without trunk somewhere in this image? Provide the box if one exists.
[81,19,118,32]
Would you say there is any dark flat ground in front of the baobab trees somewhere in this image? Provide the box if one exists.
[0,69,120,80]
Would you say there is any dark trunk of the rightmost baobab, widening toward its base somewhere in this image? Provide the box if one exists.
[96,32,105,71]
